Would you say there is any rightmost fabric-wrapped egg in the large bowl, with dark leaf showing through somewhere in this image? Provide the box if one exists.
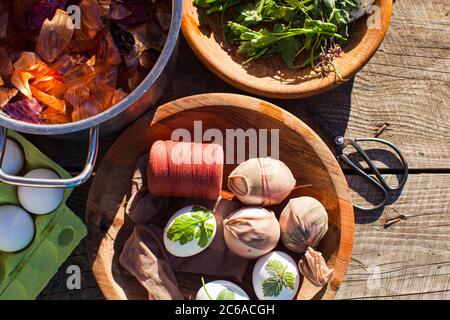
[280,197,328,253]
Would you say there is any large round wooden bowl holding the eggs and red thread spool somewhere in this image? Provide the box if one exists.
[86,94,354,299]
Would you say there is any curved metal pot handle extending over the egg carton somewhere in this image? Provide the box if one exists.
[0,126,100,188]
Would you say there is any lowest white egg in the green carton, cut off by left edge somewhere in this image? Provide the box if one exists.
[0,205,35,252]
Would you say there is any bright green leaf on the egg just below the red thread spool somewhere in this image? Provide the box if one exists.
[167,207,214,248]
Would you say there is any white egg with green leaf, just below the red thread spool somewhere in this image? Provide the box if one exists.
[164,206,217,257]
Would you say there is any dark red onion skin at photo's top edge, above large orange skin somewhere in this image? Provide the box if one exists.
[27,0,67,32]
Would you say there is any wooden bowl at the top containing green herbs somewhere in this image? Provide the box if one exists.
[181,0,392,99]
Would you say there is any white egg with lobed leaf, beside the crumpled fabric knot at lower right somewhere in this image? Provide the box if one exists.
[252,251,299,300]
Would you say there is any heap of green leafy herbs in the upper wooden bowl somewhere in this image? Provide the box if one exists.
[194,0,356,76]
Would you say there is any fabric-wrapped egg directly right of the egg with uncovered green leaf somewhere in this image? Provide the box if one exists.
[223,207,280,259]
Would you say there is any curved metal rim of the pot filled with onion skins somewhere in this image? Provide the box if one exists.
[0,0,182,135]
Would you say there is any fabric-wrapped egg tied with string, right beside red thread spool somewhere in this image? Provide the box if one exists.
[228,158,296,207]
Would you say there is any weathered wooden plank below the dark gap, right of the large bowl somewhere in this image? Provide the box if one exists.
[336,174,450,300]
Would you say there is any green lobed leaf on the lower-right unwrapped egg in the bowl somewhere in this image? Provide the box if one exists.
[263,260,295,297]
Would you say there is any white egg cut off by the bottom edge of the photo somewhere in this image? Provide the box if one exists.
[195,280,250,300]
